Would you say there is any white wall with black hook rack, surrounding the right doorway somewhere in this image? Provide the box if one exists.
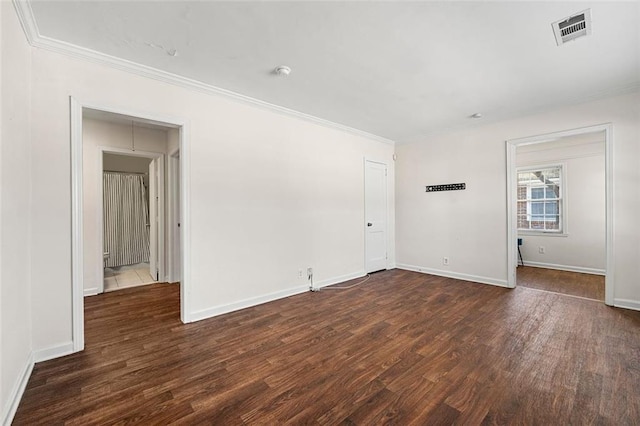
[396,93,640,309]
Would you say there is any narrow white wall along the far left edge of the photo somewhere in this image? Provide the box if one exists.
[0,2,37,424]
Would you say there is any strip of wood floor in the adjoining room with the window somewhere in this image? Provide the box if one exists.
[517,266,604,302]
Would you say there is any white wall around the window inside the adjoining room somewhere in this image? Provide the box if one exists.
[516,132,606,275]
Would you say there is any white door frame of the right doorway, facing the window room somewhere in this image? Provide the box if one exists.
[506,123,615,306]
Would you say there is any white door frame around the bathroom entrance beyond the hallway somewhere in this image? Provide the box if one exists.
[96,146,165,293]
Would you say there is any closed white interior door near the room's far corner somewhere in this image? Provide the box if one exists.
[364,160,387,273]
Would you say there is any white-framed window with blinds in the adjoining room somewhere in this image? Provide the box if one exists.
[518,165,564,233]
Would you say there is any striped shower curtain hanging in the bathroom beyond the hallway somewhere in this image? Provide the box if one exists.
[103,172,149,267]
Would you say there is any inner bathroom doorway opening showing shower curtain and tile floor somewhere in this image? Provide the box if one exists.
[101,150,160,293]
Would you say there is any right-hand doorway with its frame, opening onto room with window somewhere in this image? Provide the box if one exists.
[507,124,613,305]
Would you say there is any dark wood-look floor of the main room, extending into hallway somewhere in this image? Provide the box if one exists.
[15,270,640,425]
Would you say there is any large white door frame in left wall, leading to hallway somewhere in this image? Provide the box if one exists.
[69,96,193,352]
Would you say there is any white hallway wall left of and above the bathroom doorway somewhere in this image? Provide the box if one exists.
[82,117,167,295]
